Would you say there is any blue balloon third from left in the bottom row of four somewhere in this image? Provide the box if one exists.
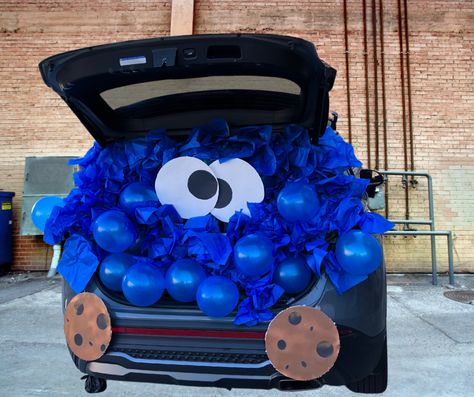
[166,259,206,302]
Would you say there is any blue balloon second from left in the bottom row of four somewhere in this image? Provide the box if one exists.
[122,263,165,306]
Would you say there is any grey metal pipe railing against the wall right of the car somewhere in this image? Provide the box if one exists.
[377,170,454,285]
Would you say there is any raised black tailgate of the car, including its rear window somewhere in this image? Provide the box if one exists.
[39,34,336,145]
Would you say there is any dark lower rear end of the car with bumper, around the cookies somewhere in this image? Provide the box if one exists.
[64,260,386,390]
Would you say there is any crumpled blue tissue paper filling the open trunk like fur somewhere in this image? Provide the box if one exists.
[44,119,393,326]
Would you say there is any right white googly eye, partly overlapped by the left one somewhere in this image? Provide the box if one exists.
[209,158,265,223]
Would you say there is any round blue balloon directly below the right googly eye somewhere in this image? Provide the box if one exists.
[234,234,274,277]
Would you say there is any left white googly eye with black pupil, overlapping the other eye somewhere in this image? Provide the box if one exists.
[155,156,219,219]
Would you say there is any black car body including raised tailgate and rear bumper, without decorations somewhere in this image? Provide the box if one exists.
[40,34,387,393]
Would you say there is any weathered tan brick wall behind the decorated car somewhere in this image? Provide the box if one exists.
[0,0,474,271]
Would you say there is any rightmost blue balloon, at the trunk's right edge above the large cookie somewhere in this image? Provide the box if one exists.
[336,230,383,276]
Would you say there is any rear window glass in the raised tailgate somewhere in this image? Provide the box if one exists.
[100,76,301,110]
